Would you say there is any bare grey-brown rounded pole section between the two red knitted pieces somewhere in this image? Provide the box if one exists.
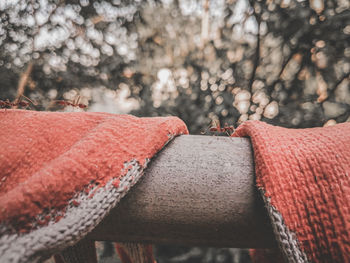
[88,135,276,248]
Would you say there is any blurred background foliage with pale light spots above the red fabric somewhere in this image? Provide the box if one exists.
[0,0,350,262]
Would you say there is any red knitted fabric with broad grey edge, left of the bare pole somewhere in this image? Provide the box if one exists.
[0,110,188,262]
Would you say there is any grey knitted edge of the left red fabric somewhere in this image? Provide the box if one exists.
[0,160,149,263]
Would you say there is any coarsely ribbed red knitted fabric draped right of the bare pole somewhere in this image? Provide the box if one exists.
[234,121,350,263]
